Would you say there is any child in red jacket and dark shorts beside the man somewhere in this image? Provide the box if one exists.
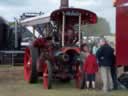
[84,51,98,88]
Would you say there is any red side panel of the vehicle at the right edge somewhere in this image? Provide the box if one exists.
[116,4,128,66]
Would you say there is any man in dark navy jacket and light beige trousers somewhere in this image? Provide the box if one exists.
[96,39,114,92]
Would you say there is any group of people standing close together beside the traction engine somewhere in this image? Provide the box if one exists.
[81,38,118,92]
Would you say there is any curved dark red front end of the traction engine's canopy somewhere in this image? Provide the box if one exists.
[50,8,97,24]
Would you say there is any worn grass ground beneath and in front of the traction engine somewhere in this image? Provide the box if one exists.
[0,66,128,96]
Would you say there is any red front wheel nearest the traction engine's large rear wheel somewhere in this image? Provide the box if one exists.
[43,61,52,89]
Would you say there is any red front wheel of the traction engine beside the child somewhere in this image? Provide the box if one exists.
[75,66,85,89]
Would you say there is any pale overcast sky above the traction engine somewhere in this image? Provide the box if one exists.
[0,0,115,32]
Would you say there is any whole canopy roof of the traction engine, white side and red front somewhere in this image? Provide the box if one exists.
[21,8,97,26]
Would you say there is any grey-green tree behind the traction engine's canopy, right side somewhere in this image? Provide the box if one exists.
[82,17,111,36]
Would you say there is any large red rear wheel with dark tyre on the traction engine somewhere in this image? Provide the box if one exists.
[24,47,38,83]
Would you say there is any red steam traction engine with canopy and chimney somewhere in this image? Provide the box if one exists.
[21,0,97,89]
